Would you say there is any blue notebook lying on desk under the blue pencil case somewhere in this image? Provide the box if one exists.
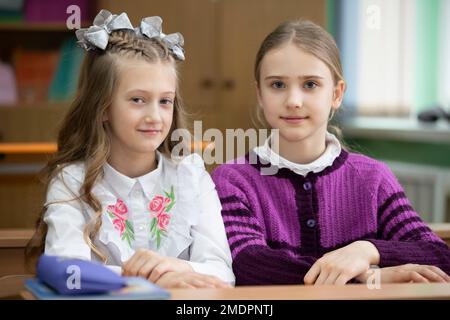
[25,277,170,300]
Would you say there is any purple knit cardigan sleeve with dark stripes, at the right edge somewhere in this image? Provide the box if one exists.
[369,165,450,274]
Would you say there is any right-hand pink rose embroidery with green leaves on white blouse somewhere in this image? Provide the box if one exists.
[148,186,175,249]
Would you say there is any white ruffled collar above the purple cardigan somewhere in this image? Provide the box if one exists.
[253,132,342,176]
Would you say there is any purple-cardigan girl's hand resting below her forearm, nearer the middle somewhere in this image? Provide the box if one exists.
[304,241,380,285]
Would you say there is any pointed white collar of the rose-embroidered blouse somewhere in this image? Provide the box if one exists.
[103,151,164,198]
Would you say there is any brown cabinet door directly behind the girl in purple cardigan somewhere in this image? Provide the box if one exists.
[216,0,325,128]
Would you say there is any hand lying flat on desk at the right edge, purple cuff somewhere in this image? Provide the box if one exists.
[357,264,450,283]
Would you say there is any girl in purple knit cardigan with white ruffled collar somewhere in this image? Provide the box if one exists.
[213,21,450,285]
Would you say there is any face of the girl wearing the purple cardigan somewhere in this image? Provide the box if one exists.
[257,43,344,142]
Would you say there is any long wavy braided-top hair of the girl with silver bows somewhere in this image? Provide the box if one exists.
[25,30,190,270]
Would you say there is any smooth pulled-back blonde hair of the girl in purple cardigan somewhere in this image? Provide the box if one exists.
[254,19,344,137]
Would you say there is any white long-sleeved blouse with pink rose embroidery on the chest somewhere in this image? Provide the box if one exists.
[44,152,235,284]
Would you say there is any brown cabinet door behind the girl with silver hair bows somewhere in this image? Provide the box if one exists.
[99,0,217,127]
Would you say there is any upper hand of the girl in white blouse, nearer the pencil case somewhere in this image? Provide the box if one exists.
[122,249,193,283]
